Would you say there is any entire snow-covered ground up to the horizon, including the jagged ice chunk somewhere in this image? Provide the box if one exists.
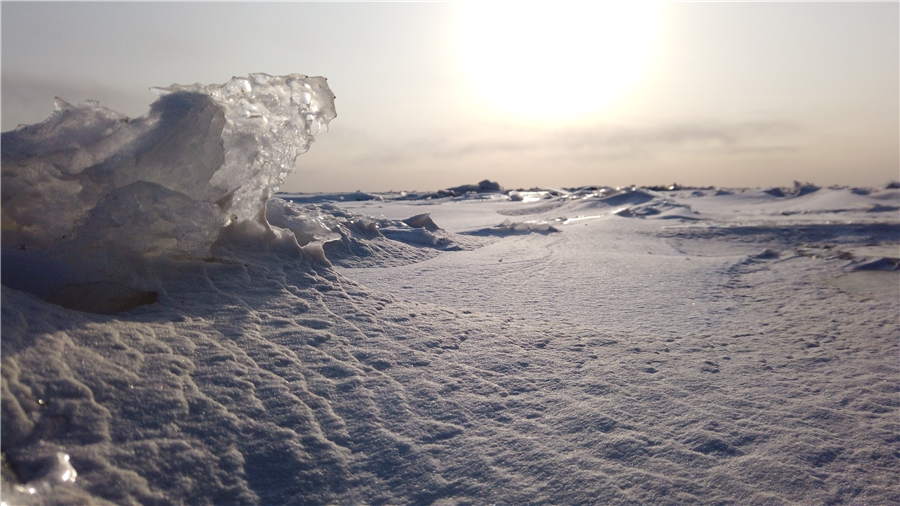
[0,75,900,505]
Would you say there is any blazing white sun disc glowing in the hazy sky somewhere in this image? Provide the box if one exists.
[458,1,658,120]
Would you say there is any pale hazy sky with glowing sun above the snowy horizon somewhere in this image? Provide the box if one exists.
[0,1,900,192]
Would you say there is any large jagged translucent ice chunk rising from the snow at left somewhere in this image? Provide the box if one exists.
[2,74,336,257]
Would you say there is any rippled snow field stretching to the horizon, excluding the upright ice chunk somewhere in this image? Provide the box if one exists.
[3,185,900,504]
